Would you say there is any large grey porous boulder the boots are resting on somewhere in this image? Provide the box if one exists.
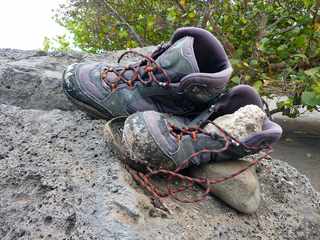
[0,49,320,239]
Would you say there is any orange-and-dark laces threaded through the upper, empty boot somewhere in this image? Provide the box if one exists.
[101,44,171,91]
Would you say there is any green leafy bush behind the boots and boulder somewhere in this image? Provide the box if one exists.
[55,0,320,117]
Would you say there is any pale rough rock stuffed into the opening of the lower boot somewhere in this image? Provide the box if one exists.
[204,105,266,139]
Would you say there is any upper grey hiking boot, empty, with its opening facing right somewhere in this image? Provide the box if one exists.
[63,27,232,119]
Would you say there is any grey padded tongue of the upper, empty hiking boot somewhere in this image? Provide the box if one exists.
[156,37,199,82]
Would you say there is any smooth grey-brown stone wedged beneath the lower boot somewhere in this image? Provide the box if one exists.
[190,160,260,213]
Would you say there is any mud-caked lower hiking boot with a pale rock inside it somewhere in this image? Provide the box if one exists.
[106,85,282,170]
